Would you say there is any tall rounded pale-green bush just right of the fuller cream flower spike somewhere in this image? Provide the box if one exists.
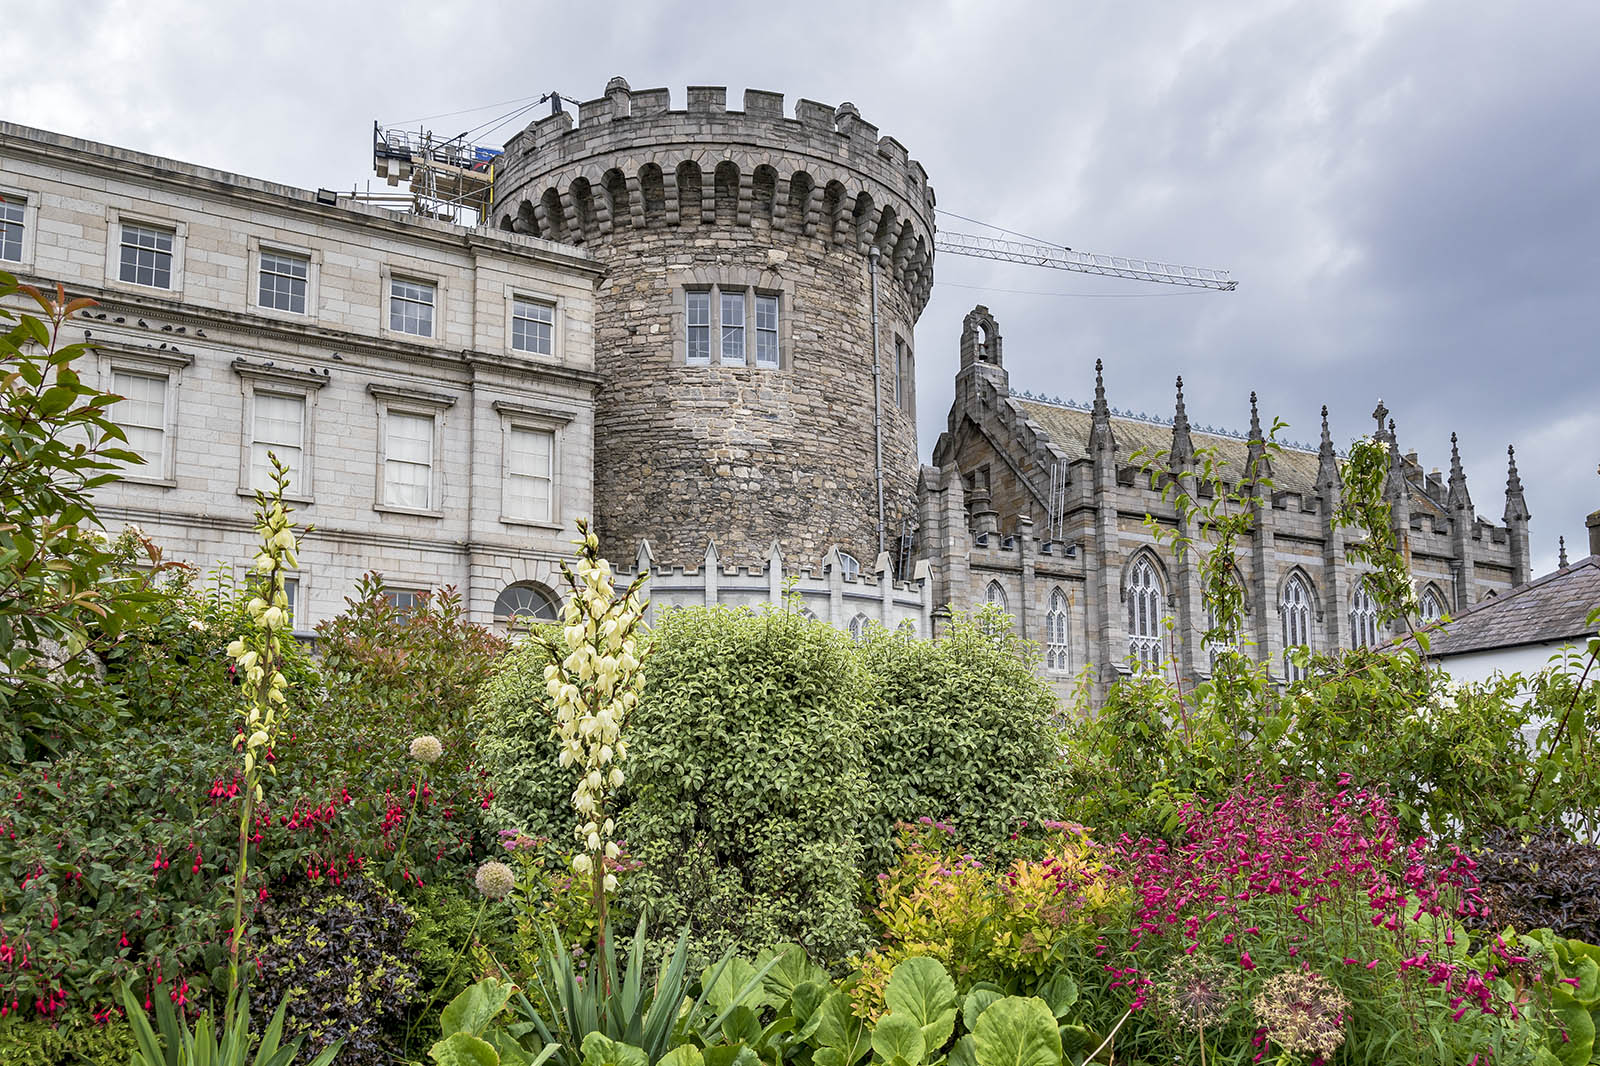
[621,608,872,960]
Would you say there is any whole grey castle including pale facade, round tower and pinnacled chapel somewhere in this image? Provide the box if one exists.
[0,78,1528,693]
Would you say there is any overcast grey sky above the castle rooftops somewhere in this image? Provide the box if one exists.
[0,0,1600,573]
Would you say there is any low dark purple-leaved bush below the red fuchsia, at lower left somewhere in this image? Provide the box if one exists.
[251,876,422,1063]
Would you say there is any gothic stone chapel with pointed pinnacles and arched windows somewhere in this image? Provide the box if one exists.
[920,307,1530,696]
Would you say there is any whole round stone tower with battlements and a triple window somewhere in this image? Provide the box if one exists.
[493,78,934,567]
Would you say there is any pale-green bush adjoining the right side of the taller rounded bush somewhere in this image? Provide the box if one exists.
[862,607,1059,872]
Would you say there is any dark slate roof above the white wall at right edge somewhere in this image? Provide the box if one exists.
[1429,555,1600,656]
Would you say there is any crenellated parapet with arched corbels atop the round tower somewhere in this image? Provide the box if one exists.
[493,78,934,314]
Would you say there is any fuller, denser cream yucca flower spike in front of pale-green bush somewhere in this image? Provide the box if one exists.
[544,528,645,892]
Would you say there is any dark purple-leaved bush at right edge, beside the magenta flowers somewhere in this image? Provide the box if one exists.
[1474,826,1600,944]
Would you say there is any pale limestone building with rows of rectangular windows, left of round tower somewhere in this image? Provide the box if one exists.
[0,116,603,631]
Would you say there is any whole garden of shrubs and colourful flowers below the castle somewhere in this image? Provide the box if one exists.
[0,279,1600,1066]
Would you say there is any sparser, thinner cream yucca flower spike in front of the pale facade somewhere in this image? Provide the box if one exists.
[227,499,299,800]
